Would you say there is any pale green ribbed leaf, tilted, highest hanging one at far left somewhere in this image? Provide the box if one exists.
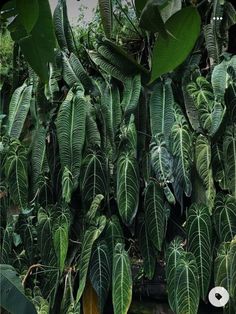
[7,83,32,139]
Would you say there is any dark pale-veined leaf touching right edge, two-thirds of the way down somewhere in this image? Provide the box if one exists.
[213,193,236,243]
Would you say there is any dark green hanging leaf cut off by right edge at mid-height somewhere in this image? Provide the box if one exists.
[223,125,236,197]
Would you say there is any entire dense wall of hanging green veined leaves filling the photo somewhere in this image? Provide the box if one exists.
[0,0,236,314]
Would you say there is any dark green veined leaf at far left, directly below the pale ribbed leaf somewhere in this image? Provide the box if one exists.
[4,142,28,208]
